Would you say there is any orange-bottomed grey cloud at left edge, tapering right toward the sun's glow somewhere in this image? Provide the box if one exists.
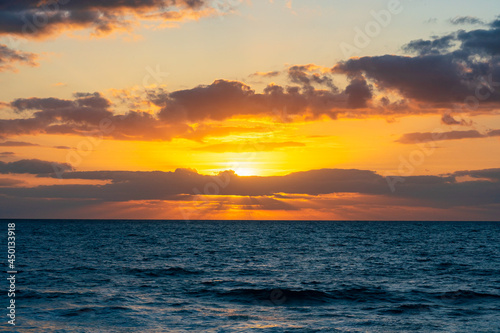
[0,93,192,140]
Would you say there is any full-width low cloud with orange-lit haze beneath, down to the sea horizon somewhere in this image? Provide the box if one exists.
[0,165,500,220]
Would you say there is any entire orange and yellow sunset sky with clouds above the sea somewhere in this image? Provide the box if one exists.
[0,0,500,220]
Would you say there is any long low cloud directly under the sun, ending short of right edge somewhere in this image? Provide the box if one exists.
[0,169,390,201]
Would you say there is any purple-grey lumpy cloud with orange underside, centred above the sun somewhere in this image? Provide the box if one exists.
[152,78,348,123]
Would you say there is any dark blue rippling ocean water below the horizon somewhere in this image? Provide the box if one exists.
[1,220,500,333]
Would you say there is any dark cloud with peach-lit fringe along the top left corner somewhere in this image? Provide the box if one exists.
[0,0,225,37]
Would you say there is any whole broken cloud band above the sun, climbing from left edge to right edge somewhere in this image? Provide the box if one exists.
[0,15,500,141]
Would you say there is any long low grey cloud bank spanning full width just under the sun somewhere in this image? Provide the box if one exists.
[0,169,500,208]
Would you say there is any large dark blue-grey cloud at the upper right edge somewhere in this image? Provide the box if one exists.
[332,21,500,110]
